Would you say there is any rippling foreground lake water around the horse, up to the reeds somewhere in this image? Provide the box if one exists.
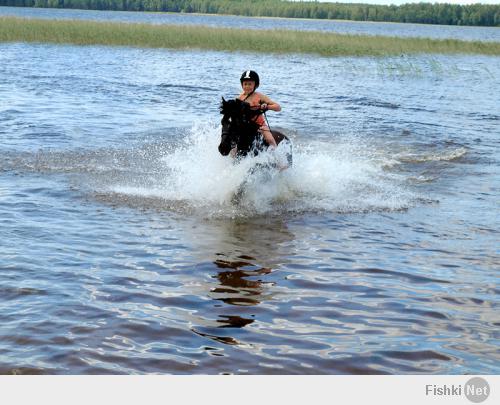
[0,11,500,374]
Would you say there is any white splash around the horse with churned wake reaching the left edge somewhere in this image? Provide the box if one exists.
[0,123,418,218]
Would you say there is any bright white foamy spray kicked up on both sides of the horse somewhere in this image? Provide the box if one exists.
[107,124,414,216]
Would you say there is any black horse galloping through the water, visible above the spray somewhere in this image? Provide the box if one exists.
[219,98,292,166]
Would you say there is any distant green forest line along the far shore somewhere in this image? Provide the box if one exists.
[0,0,500,26]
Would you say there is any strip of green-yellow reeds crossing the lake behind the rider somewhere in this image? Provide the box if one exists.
[0,17,500,56]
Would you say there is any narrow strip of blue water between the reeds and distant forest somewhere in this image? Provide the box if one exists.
[0,7,500,42]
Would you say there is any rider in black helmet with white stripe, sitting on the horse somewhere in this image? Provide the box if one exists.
[238,70,281,148]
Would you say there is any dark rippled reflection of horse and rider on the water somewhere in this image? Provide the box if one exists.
[186,218,294,348]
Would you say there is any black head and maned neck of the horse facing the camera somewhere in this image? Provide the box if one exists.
[219,98,258,156]
